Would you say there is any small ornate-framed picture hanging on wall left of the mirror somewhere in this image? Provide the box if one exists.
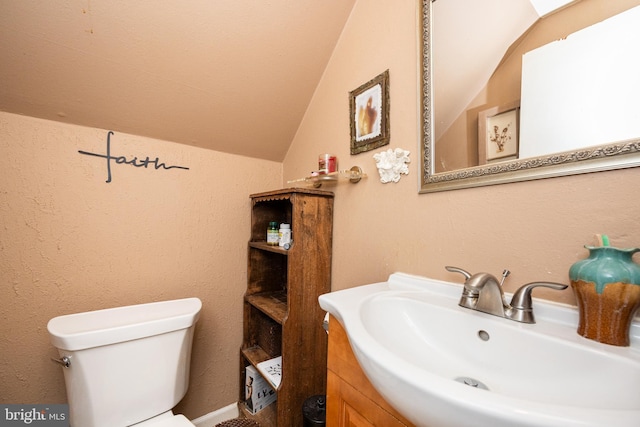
[349,70,389,154]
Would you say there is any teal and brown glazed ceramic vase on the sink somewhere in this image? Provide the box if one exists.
[569,246,640,346]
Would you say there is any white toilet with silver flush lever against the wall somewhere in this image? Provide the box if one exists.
[47,298,202,427]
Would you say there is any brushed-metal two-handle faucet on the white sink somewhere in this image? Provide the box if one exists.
[445,266,567,323]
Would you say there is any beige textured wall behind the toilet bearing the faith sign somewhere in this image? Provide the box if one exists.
[0,113,282,418]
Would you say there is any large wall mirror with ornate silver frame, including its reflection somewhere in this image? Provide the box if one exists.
[421,0,640,192]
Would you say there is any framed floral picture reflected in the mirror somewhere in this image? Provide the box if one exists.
[478,102,520,165]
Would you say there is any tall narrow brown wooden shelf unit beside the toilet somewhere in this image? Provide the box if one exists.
[238,188,334,427]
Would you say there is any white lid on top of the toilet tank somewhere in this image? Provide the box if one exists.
[47,298,202,351]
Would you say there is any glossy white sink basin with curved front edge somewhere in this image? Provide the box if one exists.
[319,273,640,427]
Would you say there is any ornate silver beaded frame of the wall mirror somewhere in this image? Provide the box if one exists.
[418,0,640,193]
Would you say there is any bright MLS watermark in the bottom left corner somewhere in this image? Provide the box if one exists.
[0,404,69,427]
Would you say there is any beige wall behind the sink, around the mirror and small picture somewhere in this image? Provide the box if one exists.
[284,0,640,304]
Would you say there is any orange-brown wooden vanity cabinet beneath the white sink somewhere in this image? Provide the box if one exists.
[326,317,413,427]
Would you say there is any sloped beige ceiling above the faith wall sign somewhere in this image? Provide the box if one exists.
[0,0,355,161]
